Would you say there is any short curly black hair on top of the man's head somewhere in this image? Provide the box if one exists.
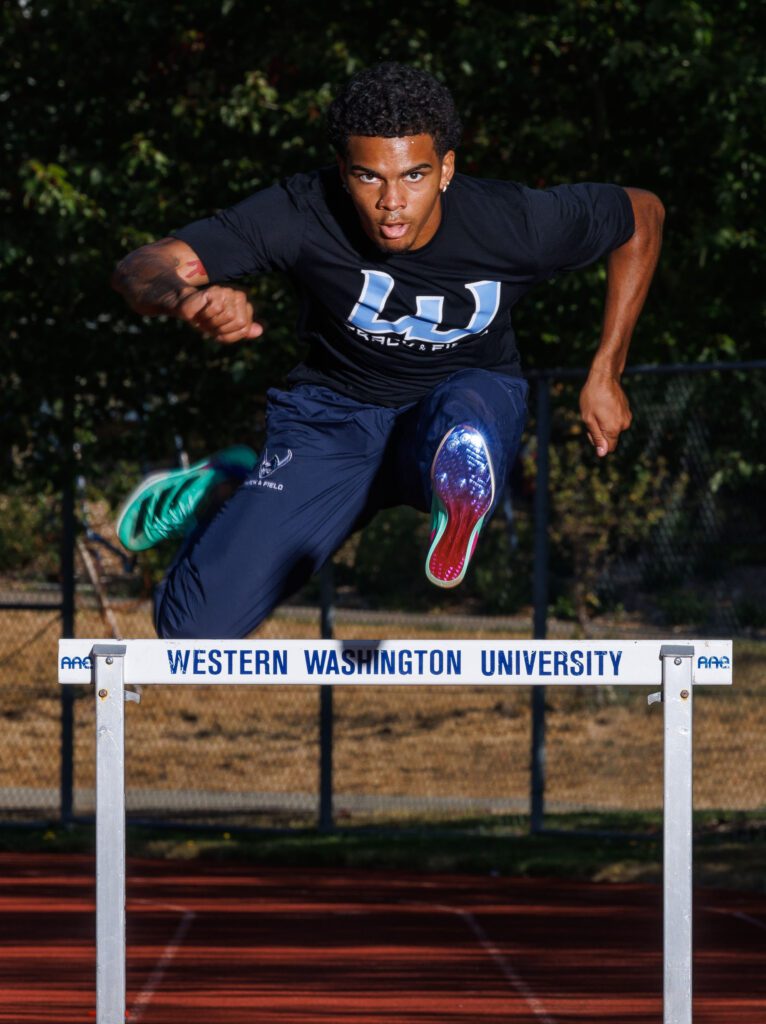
[327,60,463,159]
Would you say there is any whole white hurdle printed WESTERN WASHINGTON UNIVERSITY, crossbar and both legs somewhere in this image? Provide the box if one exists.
[58,639,732,1024]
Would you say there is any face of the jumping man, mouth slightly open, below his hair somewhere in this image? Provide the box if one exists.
[338,135,455,253]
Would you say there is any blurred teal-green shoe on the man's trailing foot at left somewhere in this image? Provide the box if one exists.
[117,444,258,551]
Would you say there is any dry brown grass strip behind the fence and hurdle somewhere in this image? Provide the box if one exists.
[0,603,766,820]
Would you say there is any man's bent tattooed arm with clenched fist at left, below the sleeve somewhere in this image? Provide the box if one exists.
[112,239,263,344]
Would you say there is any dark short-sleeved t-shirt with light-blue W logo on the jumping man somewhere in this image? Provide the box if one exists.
[176,167,634,407]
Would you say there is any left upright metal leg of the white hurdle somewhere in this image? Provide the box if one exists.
[91,644,125,1024]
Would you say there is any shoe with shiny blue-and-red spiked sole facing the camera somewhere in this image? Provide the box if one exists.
[426,423,495,587]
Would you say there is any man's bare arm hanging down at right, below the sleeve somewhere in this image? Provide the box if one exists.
[580,188,665,457]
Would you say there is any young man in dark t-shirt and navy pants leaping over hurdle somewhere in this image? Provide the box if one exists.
[115,63,663,638]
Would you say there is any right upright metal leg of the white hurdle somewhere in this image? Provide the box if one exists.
[659,644,694,1024]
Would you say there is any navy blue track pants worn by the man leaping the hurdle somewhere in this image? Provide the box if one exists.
[155,370,527,639]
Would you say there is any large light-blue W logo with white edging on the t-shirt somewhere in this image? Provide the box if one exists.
[348,270,500,345]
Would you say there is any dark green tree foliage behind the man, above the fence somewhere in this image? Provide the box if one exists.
[0,0,766,470]
